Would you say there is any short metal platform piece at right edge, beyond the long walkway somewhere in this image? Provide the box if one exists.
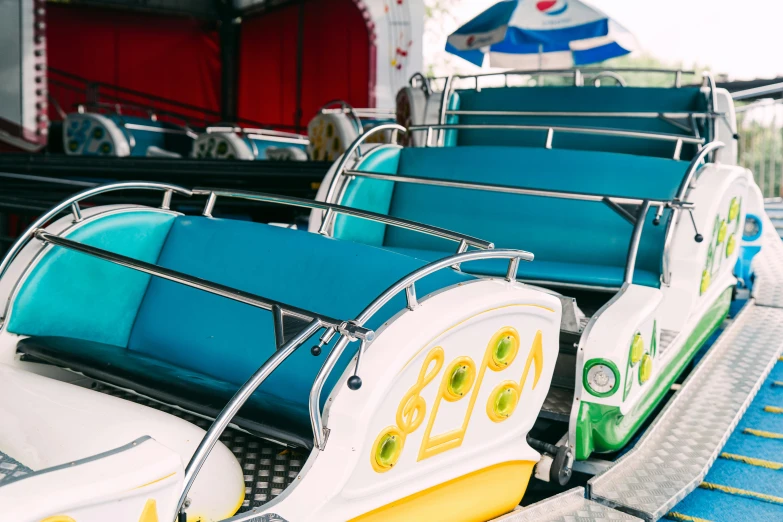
[752,214,783,308]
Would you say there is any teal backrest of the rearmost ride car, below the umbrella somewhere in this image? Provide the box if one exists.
[450,87,707,159]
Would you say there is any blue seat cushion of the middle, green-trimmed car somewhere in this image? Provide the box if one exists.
[387,247,660,288]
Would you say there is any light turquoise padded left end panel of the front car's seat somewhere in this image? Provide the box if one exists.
[8,210,175,346]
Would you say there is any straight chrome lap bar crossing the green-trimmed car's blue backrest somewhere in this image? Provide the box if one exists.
[346,170,690,208]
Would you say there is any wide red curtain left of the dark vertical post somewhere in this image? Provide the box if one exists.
[46,4,220,124]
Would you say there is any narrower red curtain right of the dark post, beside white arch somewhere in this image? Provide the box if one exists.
[238,0,371,126]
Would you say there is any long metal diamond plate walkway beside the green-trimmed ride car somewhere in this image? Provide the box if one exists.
[588,301,783,520]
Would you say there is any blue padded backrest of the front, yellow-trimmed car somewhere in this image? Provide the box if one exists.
[128,216,473,444]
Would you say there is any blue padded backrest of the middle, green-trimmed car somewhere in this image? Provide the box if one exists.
[362,146,688,282]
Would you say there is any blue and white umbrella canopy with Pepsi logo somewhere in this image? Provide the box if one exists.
[446,0,637,69]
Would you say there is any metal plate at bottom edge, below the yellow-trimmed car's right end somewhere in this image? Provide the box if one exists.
[492,488,639,522]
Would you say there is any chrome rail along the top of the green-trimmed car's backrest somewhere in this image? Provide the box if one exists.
[408,123,705,159]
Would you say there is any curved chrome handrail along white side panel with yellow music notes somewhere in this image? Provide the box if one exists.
[309,250,534,450]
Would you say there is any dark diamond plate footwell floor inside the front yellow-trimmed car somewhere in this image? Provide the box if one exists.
[90,383,307,513]
